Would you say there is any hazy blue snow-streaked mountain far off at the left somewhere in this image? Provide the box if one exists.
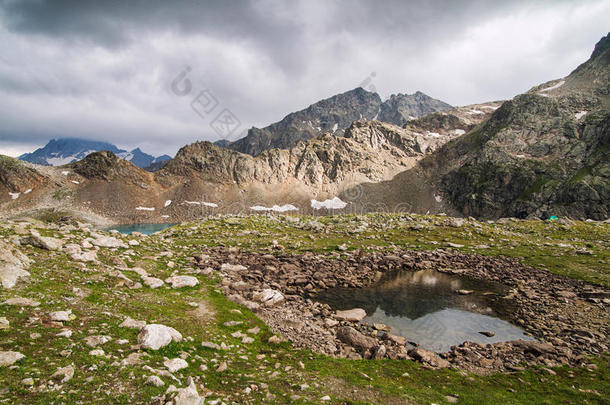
[19,138,171,169]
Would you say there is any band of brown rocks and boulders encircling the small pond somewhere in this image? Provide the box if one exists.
[192,248,610,374]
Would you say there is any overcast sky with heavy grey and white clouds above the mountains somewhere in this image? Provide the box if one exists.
[0,0,610,156]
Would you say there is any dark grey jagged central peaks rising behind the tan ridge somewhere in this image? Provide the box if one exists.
[215,87,452,156]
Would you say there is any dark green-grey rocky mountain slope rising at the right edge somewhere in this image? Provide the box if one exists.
[346,36,610,219]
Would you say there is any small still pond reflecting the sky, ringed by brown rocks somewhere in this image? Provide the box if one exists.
[316,270,534,353]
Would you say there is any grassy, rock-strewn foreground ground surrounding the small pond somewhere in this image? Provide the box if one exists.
[0,214,610,404]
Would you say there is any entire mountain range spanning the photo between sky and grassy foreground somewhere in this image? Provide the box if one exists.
[0,34,610,223]
